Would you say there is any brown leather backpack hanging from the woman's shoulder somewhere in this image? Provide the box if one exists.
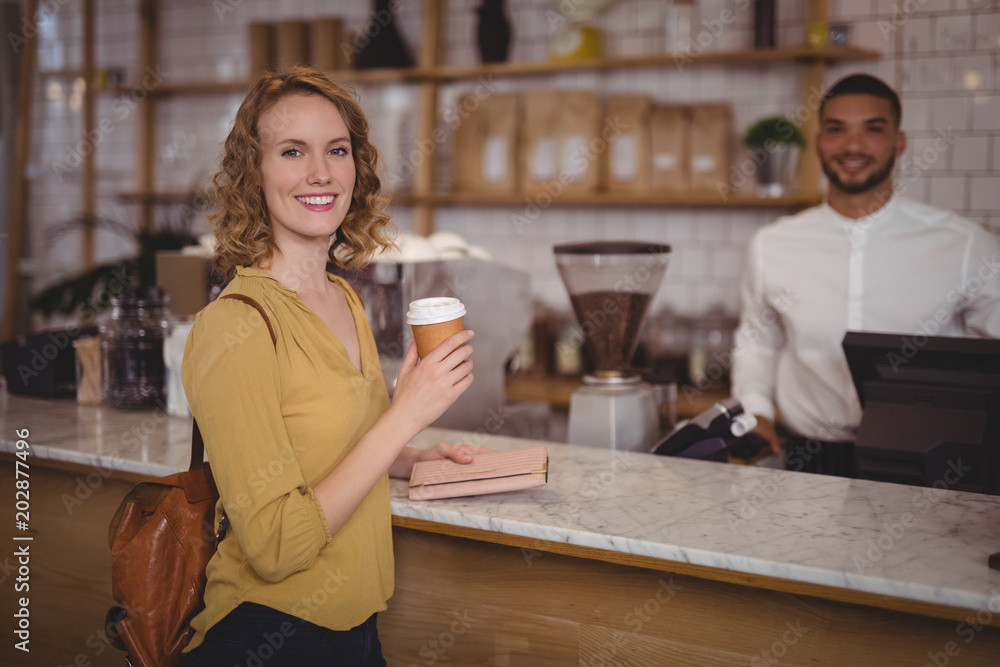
[105,294,276,667]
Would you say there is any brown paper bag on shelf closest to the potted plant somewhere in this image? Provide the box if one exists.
[690,104,733,193]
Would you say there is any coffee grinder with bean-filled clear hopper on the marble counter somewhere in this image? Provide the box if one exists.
[554,241,670,452]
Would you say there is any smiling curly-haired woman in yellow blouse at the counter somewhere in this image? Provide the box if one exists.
[182,68,478,667]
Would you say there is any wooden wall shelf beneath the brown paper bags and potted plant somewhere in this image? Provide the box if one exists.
[392,192,823,208]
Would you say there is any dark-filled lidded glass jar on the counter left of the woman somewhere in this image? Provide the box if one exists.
[101,287,170,408]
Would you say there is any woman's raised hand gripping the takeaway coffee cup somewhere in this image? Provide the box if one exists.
[389,331,473,433]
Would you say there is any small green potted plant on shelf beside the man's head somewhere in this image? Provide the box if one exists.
[743,116,806,197]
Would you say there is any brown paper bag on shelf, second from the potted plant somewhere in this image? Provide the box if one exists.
[650,105,691,192]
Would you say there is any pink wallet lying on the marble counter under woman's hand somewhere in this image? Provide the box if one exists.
[410,446,549,500]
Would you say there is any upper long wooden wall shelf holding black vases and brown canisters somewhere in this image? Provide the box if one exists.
[86,46,880,96]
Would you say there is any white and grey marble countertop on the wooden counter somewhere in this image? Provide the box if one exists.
[0,395,1000,610]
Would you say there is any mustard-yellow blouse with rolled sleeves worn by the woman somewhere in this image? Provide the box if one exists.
[182,267,393,650]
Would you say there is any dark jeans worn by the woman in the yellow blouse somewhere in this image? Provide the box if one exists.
[183,602,385,667]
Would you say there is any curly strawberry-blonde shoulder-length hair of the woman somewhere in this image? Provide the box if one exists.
[208,66,392,274]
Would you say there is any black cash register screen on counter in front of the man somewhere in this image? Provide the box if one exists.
[843,331,1000,495]
